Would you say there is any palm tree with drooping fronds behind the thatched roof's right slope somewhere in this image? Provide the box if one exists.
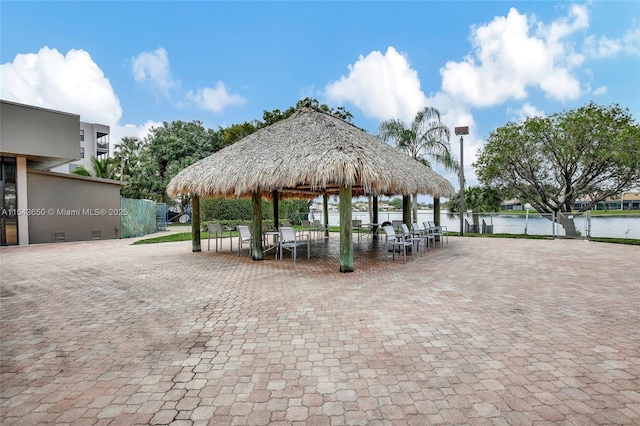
[379,107,459,225]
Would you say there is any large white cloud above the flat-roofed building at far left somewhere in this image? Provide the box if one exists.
[0,47,122,126]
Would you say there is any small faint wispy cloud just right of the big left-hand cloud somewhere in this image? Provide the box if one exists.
[132,47,180,96]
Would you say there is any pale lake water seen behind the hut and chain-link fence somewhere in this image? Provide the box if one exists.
[312,210,640,239]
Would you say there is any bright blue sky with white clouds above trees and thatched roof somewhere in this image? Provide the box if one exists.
[0,0,640,195]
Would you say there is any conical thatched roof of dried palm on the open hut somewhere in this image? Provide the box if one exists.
[167,107,454,198]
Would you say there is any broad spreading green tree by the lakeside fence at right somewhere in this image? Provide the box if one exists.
[474,102,640,236]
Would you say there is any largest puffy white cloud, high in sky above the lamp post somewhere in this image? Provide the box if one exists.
[440,5,588,107]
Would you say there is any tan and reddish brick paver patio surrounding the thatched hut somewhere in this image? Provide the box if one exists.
[0,238,640,425]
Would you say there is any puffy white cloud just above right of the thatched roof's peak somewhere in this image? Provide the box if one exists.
[325,46,426,122]
